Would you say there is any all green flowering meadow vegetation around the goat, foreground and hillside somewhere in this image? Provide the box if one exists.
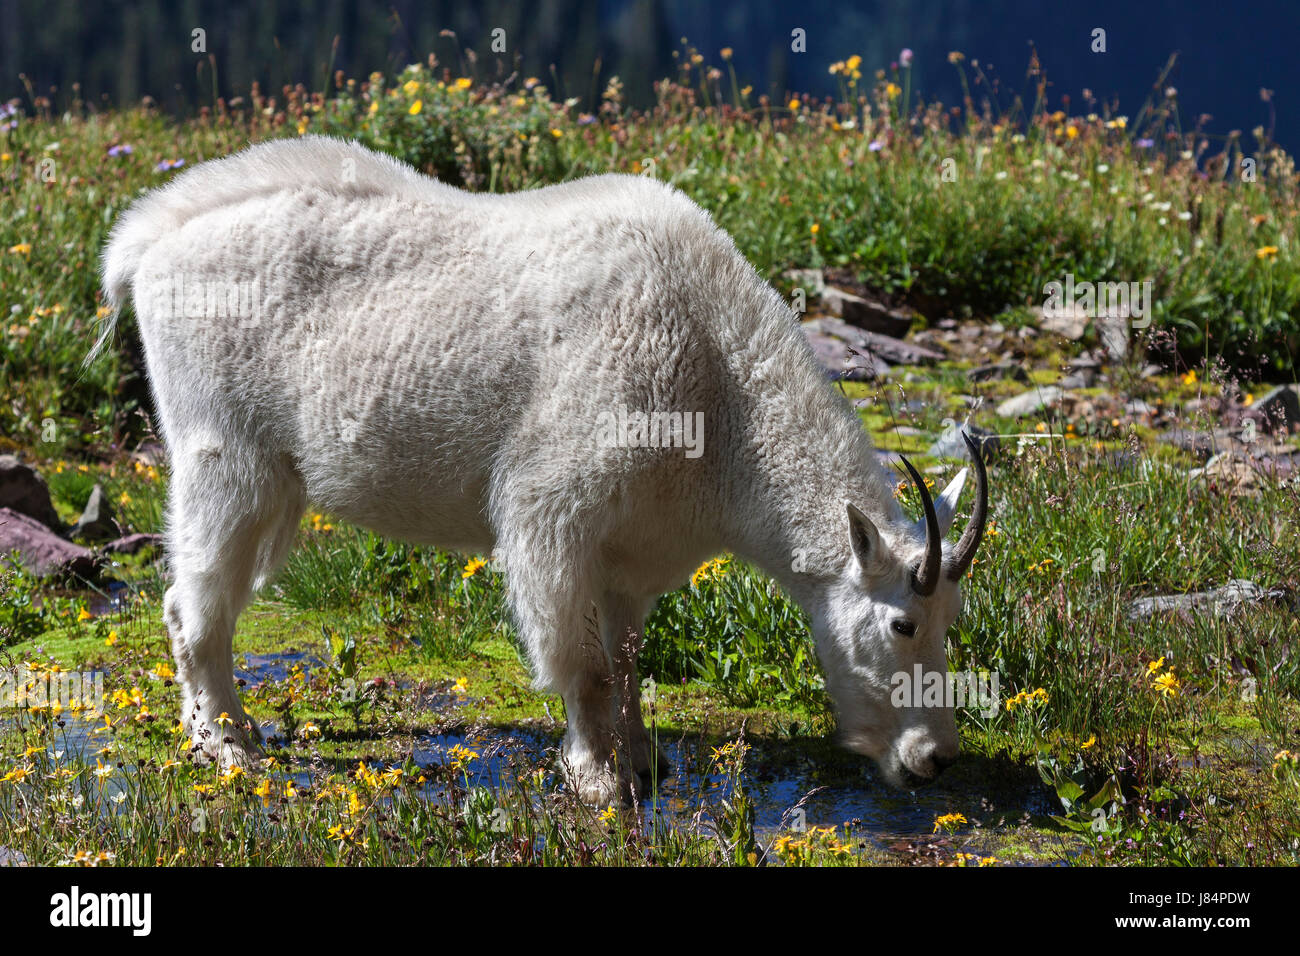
[0,47,1300,865]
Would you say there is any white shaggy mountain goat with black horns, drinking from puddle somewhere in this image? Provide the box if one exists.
[87,138,988,804]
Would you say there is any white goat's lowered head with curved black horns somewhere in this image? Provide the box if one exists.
[816,433,988,787]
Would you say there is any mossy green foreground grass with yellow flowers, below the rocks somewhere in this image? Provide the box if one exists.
[0,395,1300,865]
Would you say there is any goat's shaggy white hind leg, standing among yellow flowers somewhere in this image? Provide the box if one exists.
[163,446,293,765]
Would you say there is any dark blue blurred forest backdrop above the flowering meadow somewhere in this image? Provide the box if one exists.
[0,0,1300,150]
